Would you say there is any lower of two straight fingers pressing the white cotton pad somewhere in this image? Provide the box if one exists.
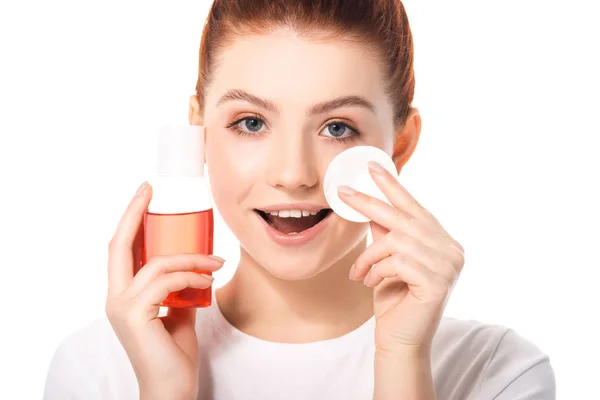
[338,186,414,231]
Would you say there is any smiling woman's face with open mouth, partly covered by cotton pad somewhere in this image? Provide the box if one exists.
[195,30,395,280]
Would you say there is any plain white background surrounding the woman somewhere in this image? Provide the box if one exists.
[0,0,600,399]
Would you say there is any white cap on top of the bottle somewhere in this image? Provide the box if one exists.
[156,125,204,177]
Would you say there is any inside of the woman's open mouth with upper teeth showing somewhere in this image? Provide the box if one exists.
[254,208,331,236]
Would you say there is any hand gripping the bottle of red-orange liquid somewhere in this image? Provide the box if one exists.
[106,184,223,400]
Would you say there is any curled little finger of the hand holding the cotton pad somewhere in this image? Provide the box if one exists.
[364,254,450,301]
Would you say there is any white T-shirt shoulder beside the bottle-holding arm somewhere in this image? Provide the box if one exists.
[44,318,137,400]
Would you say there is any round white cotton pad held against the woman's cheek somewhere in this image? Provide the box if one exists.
[323,146,398,222]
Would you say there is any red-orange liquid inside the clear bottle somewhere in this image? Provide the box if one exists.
[142,209,214,308]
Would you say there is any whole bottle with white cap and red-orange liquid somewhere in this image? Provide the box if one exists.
[136,125,214,308]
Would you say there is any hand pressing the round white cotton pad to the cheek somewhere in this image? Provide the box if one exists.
[339,163,464,354]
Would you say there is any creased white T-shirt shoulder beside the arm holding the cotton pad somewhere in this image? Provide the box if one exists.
[432,318,555,400]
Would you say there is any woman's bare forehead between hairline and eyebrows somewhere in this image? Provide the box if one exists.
[206,30,385,107]
